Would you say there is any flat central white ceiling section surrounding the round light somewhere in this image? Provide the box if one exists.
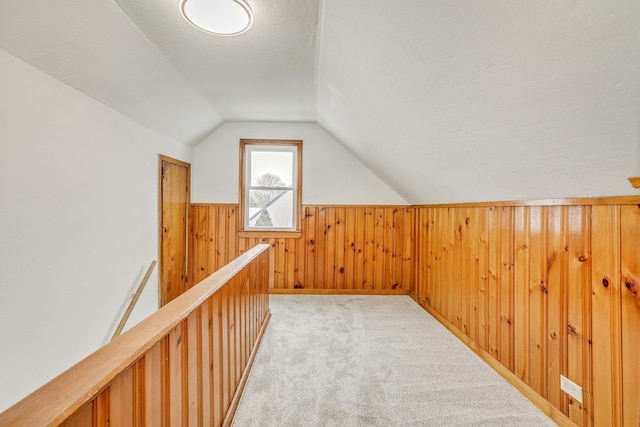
[116,0,318,121]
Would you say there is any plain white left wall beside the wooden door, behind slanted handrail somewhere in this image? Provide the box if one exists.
[0,49,191,411]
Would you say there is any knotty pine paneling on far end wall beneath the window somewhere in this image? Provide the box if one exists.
[189,204,415,293]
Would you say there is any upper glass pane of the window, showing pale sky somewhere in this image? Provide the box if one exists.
[251,151,293,187]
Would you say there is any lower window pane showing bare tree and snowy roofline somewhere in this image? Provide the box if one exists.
[249,190,294,228]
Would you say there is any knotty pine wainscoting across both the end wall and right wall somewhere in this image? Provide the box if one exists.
[190,197,640,427]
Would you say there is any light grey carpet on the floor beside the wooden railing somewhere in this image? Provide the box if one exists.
[234,295,555,427]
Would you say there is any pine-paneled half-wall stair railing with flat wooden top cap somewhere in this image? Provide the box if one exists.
[0,245,270,426]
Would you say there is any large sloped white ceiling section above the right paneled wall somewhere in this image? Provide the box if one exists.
[318,0,640,203]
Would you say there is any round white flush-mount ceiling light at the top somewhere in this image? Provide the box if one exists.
[180,0,253,36]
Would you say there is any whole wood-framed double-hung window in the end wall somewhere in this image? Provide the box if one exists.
[240,139,302,236]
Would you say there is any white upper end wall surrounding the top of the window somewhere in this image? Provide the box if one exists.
[191,122,407,205]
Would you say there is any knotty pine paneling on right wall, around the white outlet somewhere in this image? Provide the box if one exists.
[411,199,640,427]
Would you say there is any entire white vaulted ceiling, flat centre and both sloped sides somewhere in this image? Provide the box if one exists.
[0,0,640,203]
